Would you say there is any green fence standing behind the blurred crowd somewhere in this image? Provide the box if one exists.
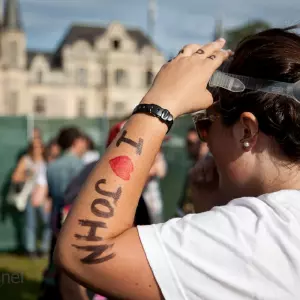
[0,117,192,251]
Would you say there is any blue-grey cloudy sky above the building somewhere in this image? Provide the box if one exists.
[14,0,300,56]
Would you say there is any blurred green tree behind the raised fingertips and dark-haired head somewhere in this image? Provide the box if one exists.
[226,20,271,50]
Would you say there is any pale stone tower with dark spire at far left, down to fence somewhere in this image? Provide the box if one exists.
[0,0,28,115]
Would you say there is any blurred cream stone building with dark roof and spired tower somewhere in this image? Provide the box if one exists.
[0,0,165,118]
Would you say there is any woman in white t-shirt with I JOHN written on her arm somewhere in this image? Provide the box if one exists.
[56,29,300,300]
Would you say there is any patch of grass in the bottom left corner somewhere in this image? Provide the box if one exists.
[0,254,47,300]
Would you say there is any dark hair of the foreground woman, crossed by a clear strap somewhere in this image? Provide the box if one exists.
[218,26,300,161]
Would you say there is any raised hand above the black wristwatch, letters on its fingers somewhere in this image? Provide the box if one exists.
[142,39,232,118]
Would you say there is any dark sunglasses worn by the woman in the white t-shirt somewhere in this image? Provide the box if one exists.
[192,101,220,142]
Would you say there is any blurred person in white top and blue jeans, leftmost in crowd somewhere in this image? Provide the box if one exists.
[12,138,51,258]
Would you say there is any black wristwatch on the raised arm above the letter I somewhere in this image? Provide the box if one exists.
[132,104,174,133]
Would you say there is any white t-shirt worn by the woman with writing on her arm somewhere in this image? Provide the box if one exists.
[138,190,300,300]
